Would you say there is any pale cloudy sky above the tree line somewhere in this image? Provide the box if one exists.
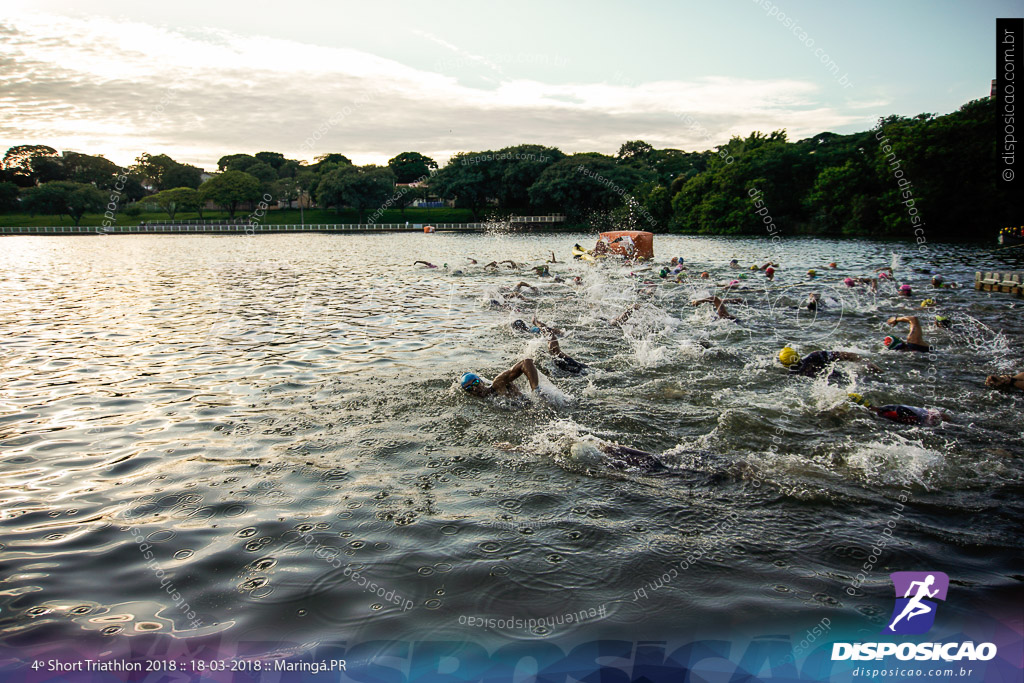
[0,0,1024,170]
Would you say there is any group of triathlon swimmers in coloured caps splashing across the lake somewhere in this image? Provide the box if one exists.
[416,253,1024,470]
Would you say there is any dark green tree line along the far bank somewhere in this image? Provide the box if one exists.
[0,98,1007,240]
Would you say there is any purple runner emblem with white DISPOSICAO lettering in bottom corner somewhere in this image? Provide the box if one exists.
[831,571,996,661]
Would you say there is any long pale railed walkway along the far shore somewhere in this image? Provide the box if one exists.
[0,215,565,236]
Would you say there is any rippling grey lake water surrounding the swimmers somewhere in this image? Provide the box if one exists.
[0,233,1024,643]
